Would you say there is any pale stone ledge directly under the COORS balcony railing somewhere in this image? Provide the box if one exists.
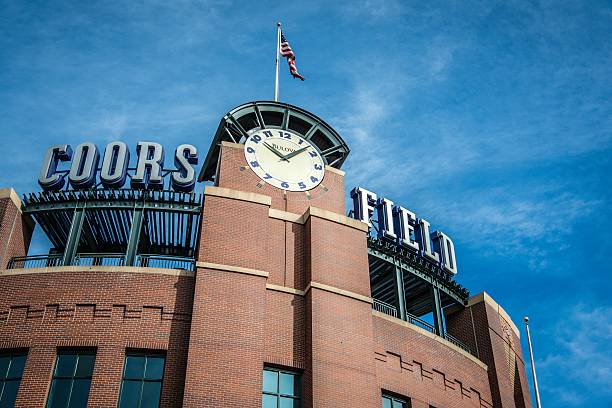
[0,265,195,278]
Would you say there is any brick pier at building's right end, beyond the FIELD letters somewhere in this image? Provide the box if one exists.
[446,292,531,408]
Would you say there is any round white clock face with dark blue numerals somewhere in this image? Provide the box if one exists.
[244,129,325,191]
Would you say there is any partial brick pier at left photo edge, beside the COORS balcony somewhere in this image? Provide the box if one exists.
[0,188,34,269]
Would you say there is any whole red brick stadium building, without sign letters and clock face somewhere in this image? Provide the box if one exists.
[0,102,531,408]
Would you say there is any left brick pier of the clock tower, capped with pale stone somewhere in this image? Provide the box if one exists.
[183,187,271,408]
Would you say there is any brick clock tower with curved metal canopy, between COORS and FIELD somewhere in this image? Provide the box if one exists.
[183,102,380,408]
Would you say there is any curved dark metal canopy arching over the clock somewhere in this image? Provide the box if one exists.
[198,101,350,181]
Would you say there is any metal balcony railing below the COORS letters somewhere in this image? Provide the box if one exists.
[7,253,195,271]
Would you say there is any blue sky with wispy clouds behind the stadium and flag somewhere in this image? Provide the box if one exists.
[0,0,612,407]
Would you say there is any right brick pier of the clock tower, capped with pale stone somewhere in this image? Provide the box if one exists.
[304,207,381,408]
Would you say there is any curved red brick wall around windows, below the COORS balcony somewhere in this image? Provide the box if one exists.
[0,267,194,408]
